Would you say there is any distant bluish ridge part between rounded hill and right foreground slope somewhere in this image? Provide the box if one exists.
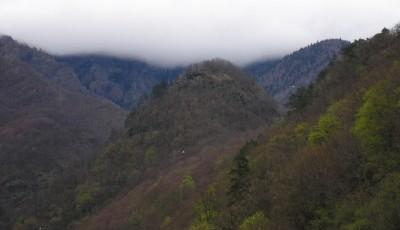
[245,39,350,104]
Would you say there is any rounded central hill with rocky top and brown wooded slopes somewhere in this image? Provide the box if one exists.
[76,60,278,229]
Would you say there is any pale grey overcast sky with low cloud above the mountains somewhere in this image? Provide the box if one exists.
[0,0,400,65]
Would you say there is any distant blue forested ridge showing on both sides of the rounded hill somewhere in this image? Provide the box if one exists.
[57,39,349,109]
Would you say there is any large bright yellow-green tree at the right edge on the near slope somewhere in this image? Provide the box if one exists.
[353,81,400,180]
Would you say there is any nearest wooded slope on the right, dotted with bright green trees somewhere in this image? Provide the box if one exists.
[190,26,400,230]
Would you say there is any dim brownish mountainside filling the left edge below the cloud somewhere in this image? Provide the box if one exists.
[0,37,125,229]
